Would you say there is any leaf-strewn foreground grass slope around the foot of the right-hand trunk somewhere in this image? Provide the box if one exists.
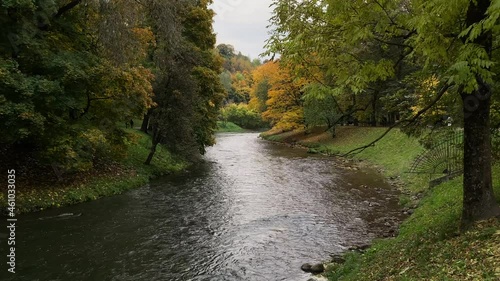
[326,165,500,281]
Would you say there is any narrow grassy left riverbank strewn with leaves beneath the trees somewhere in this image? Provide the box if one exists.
[0,129,187,213]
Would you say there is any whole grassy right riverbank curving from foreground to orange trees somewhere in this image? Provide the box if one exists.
[262,127,500,280]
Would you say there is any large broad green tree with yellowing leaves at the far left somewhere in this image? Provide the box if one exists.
[0,0,152,171]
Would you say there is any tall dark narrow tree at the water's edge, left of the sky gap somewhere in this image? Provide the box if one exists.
[145,1,225,164]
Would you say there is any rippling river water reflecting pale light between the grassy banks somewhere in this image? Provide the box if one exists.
[0,133,401,281]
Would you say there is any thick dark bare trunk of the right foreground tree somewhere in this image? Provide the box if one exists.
[462,87,500,228]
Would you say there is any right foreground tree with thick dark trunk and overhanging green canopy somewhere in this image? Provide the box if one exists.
[267,0,500,226]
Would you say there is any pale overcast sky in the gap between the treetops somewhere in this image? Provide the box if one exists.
[211,0,272,59]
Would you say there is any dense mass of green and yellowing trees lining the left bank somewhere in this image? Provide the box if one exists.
[0,0,225,172]
